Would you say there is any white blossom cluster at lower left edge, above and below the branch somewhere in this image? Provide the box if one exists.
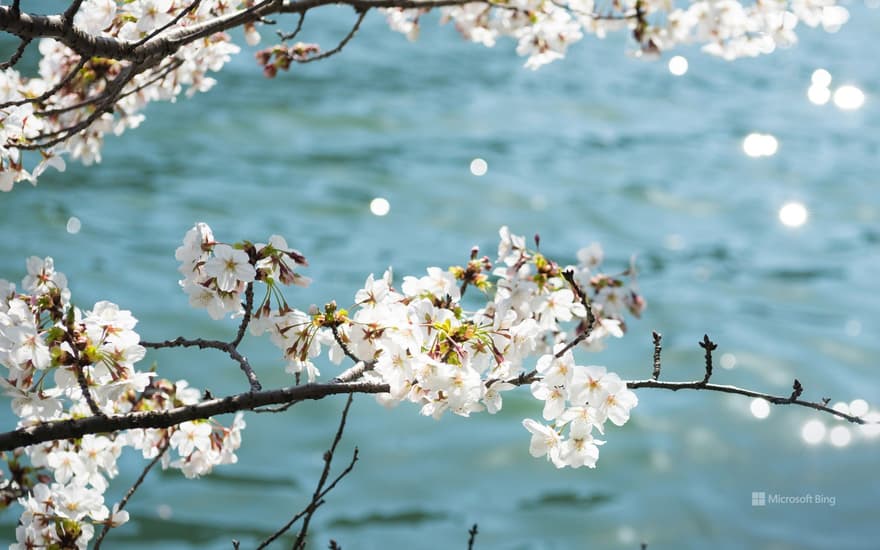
[0,257,244,549]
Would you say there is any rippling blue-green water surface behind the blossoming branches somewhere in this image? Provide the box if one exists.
[0,3,880,550]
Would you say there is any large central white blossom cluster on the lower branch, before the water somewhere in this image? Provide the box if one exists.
[178,224,645,467]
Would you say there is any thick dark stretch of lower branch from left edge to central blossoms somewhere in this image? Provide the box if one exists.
[0,382,390,451]
